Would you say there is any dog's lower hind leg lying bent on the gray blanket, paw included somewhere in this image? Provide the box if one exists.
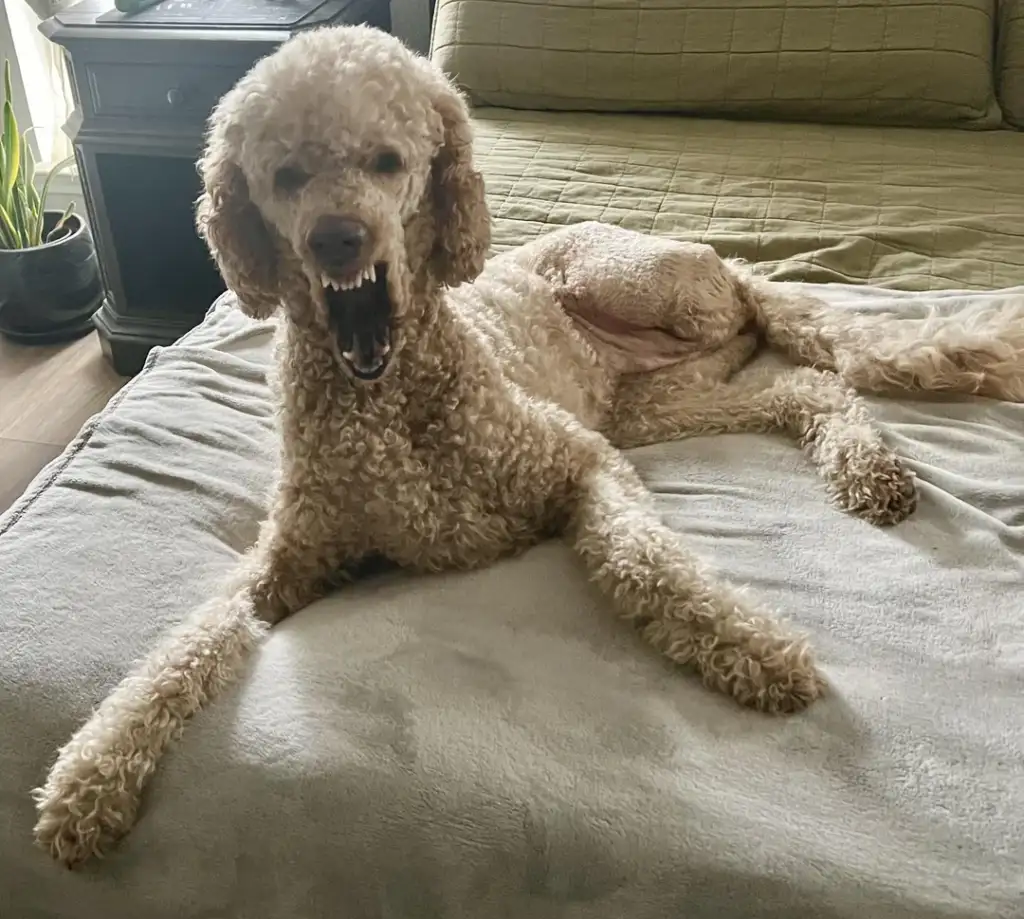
[603,362,916,526]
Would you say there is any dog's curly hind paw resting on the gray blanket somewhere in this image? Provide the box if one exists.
[827,441,918,527]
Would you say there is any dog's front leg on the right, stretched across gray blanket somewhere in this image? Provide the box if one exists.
[567,451,824,713]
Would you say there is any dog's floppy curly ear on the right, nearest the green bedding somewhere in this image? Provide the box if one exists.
[431,78,490,287]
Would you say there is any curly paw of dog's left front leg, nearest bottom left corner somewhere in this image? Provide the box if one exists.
[33,758,138,868]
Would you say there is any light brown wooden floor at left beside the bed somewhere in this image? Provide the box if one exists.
[0,333,126,513]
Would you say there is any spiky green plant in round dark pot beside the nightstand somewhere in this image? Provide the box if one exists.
[0,60,102,344]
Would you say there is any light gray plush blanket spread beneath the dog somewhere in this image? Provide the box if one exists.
[0,287,1024,919]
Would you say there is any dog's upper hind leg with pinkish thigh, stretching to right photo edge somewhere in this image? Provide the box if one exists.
[514,222,1024,402]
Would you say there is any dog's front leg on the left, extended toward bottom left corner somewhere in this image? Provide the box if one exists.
[34,491,358,866]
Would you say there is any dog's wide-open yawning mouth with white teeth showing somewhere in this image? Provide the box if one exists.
[321,262,391,380]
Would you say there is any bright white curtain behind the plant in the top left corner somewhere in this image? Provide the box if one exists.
[0,0,75,169]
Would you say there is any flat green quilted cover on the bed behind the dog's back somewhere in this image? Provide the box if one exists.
[476,108,1024,290]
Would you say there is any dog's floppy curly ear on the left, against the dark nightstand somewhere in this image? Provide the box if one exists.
[196,144,281,319]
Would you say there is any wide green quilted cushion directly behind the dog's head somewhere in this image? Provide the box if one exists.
[432,0,1000,127]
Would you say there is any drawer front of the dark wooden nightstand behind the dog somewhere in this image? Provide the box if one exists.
[85,61,247,122]
